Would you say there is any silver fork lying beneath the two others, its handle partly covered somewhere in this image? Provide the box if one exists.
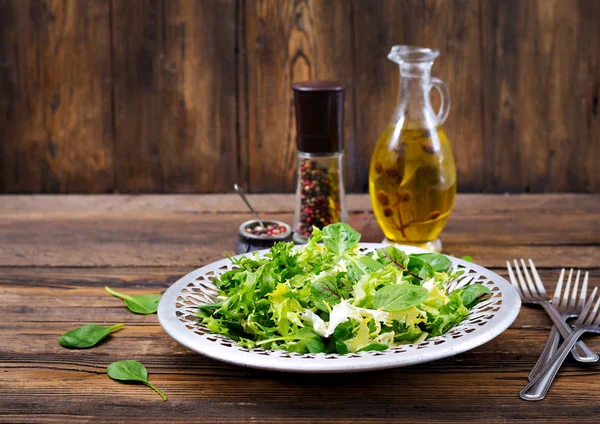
[527,266,589,381]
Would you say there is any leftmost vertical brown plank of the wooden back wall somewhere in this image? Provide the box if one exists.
[0,0,113,193]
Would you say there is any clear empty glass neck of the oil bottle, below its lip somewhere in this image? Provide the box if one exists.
[394,62,437,127]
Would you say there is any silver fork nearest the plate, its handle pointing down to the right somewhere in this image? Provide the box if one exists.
[506,259,600,362]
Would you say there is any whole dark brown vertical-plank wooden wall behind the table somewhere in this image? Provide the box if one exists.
[0,0,600,193]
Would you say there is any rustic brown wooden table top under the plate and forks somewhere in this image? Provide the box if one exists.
[0,194,600,423]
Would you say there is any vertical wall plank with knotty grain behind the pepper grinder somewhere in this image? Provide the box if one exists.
[244,0,358,192]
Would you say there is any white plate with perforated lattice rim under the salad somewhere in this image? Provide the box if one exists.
[158,243,521,373]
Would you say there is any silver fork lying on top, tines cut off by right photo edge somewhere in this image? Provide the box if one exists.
[519,287,600,400]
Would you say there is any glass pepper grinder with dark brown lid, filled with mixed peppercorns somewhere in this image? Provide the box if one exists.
[292,81,347,243]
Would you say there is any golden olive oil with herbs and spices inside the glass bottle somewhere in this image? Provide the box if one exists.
[369,126,456,245]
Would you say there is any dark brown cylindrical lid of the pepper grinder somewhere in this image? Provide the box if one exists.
[292,80,344,153]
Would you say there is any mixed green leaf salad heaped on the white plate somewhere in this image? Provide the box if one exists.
[197,223,489,354]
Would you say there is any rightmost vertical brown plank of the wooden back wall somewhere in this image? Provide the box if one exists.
[482,0,600,192]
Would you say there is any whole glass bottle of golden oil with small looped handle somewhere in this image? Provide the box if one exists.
[369,46,456,251]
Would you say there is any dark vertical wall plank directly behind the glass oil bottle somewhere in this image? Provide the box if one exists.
[353,0,487,192]
